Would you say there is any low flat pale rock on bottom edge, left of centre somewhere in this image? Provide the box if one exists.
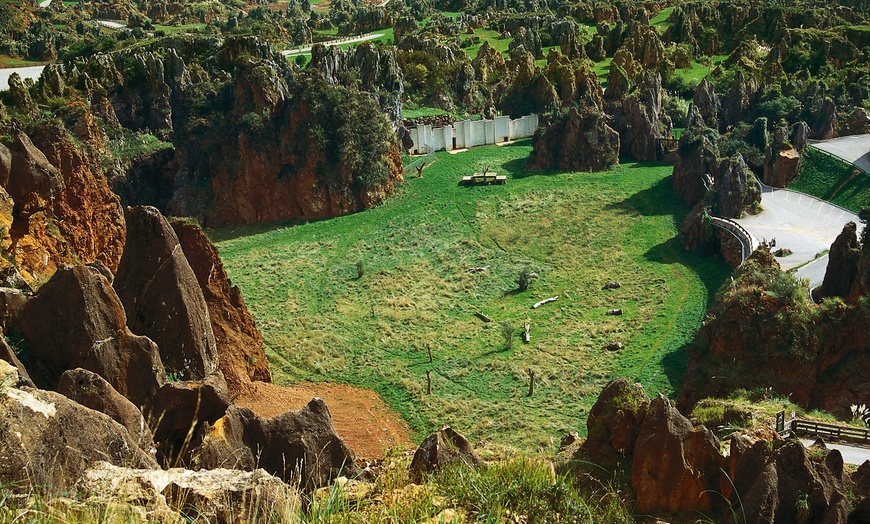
[76,462,301,524]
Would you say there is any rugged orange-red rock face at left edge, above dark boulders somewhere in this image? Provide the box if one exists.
[0,126,126,283]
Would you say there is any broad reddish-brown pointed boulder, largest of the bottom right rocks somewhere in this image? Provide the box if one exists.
[631,395,722,513]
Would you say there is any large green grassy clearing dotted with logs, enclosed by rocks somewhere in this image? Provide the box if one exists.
[214,140,729,449]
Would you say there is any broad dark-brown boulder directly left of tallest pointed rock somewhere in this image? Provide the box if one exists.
[17,266,166,406]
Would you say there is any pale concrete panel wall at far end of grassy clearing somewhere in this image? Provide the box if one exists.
[408,114,538,155]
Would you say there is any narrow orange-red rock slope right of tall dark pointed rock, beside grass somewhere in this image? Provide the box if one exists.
[172,221,272,395]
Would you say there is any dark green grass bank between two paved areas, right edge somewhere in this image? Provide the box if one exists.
[788,147,870,213]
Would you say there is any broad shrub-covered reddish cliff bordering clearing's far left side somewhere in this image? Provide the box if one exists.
[5,37,402,227]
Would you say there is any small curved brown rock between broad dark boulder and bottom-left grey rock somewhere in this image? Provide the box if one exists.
[57,368,153,451]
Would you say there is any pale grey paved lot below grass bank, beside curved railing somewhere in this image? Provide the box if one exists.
[735,187,858,287]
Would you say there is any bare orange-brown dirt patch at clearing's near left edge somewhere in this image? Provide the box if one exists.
[235,382,415,460]
